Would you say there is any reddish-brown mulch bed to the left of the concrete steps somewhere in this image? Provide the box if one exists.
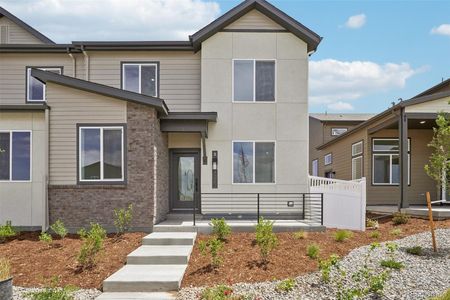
[0,232,145,289]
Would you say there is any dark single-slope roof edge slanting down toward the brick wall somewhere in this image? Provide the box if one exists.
[31,69,169,115]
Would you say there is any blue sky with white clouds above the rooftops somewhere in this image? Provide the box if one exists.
[0,0,450,113]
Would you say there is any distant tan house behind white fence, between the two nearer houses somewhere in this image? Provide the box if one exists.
[309,113,374,178]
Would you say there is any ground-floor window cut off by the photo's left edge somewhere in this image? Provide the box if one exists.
[0,131,31,181]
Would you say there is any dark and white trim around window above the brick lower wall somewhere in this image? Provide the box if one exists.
[77,123,128,185]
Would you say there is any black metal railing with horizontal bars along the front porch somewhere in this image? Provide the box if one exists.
[193,193,323,225]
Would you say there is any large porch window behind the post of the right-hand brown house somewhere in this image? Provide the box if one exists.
[372,139,411,185]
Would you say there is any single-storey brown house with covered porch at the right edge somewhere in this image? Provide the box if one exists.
[317,79,450,208]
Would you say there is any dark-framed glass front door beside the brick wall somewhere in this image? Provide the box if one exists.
[169,149,200,212]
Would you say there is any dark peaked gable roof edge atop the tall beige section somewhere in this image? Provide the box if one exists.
[189,0,322,52]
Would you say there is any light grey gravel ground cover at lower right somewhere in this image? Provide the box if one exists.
[177,229,450,300]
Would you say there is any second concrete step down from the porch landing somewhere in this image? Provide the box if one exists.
[127,245,192,265]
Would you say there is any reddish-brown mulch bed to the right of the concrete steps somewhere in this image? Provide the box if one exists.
[182,218,450,287]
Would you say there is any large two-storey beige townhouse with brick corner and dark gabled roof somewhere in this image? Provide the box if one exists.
[0,0,321,230]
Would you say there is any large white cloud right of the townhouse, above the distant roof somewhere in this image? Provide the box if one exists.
[309,59,423,110]
